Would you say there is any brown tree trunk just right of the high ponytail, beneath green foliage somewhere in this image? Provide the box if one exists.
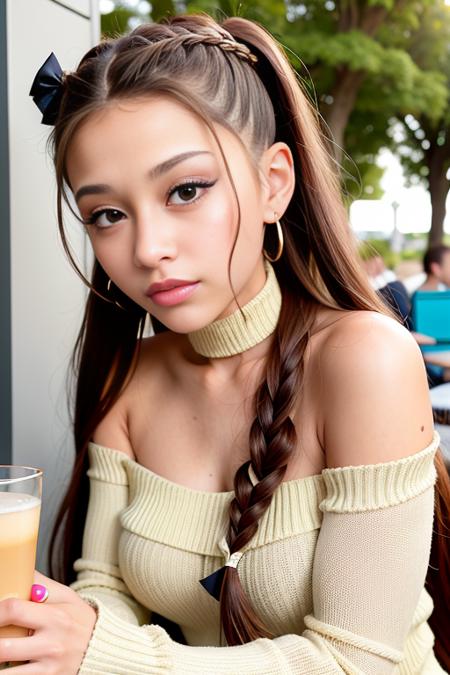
[322,68,365,164]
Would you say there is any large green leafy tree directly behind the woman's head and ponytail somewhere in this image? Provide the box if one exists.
[102,0,447,235]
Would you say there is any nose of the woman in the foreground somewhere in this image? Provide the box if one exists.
[134,216,177,267]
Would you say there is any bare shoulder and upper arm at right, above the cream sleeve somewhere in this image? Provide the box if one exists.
[316,311,433,467]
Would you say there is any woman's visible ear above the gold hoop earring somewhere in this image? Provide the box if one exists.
[260,142,295,223]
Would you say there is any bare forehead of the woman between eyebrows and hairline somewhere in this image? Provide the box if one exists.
[66,97,223,185]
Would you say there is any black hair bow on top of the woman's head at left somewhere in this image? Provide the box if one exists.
[29,52,63,125]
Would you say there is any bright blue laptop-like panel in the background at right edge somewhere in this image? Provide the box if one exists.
[411,290,450,352]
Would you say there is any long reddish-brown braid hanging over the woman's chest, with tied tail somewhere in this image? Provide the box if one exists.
[220,294,307,644]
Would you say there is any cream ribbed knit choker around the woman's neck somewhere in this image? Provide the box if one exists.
[187,260,281,358]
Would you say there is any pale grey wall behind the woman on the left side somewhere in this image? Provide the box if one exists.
[4,0,99,574]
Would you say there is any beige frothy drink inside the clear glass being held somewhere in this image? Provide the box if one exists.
[0,492,41,637]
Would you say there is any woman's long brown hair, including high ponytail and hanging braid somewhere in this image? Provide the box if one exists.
[49,15,450,666]
